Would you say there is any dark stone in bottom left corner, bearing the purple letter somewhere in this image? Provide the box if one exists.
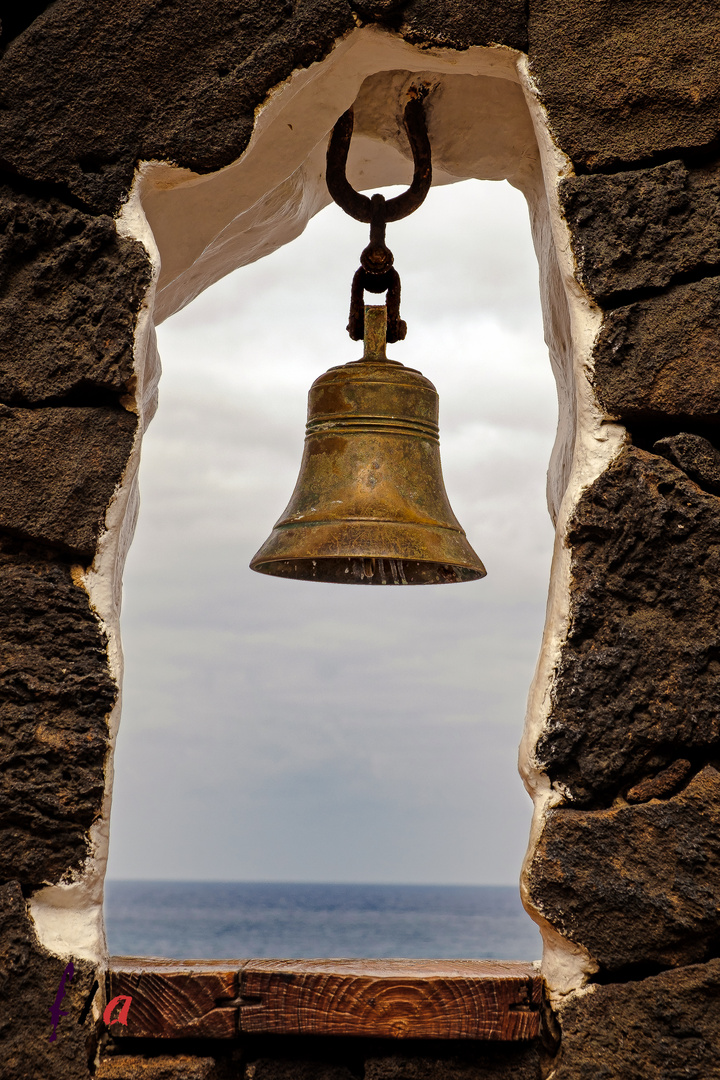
[0,881,96,1080]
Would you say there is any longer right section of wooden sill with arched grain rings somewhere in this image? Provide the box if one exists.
[240,960,542,1040]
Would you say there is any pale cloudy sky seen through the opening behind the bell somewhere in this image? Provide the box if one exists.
[108,180,557,885]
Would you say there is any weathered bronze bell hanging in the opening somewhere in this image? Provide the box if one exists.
[250,306,486,585]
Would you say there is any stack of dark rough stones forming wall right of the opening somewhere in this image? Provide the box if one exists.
[526,2,720,1067]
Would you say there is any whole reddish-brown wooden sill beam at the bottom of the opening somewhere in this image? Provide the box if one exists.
[108,957,542,1040]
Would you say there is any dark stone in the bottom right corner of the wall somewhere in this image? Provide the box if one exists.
[552,960,720,1080]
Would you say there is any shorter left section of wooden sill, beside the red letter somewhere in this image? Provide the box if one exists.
[108,956,239,1039]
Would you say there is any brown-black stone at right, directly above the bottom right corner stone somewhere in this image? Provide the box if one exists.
[528,766,720,972]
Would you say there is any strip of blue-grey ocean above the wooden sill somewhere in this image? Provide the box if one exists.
[105,881,541,960]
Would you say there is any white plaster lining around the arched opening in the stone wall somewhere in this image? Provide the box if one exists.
[30,27,623,995]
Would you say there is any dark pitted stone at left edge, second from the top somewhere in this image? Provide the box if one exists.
[0,187,150,405]
